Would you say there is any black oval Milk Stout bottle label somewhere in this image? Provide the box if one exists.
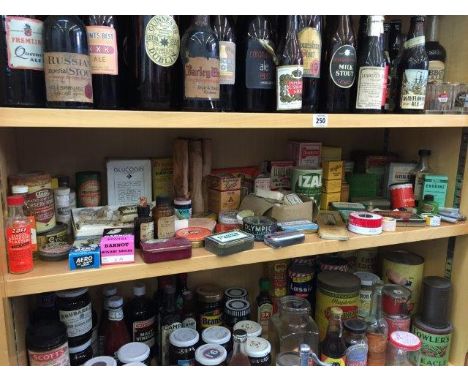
[330,45,356,88]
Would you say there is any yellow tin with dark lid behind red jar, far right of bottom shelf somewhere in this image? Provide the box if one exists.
[382,250,424,315]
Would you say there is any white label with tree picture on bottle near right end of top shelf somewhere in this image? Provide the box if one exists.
[400,69,429,110]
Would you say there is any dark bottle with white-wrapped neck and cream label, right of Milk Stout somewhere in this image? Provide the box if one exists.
[355,16,387,113]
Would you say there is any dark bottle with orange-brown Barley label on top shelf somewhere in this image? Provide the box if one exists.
[181,16,220,111]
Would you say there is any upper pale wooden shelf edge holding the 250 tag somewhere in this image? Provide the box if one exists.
[0,108,468,129]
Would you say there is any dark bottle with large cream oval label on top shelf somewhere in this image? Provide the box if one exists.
[128,15,181,110]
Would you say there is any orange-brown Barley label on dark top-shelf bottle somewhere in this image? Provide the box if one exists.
[184,57,219,100]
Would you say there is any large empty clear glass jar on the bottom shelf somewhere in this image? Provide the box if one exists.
[268,296,319,364]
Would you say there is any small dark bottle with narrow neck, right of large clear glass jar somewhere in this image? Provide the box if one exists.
[320,307,346,366]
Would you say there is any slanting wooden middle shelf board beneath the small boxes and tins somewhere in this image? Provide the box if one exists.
[5,223,468,297]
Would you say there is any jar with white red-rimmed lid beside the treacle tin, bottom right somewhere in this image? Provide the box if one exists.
[385,331,421,366]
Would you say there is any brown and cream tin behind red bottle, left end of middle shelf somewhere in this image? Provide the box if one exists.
[9,172,56,234]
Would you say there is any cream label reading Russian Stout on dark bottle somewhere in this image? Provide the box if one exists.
[44,52,93,103]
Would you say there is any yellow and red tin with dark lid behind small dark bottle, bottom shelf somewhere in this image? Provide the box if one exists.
[315,271,361,341]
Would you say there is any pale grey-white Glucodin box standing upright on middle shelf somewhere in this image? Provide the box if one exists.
[107,159,153,206]
